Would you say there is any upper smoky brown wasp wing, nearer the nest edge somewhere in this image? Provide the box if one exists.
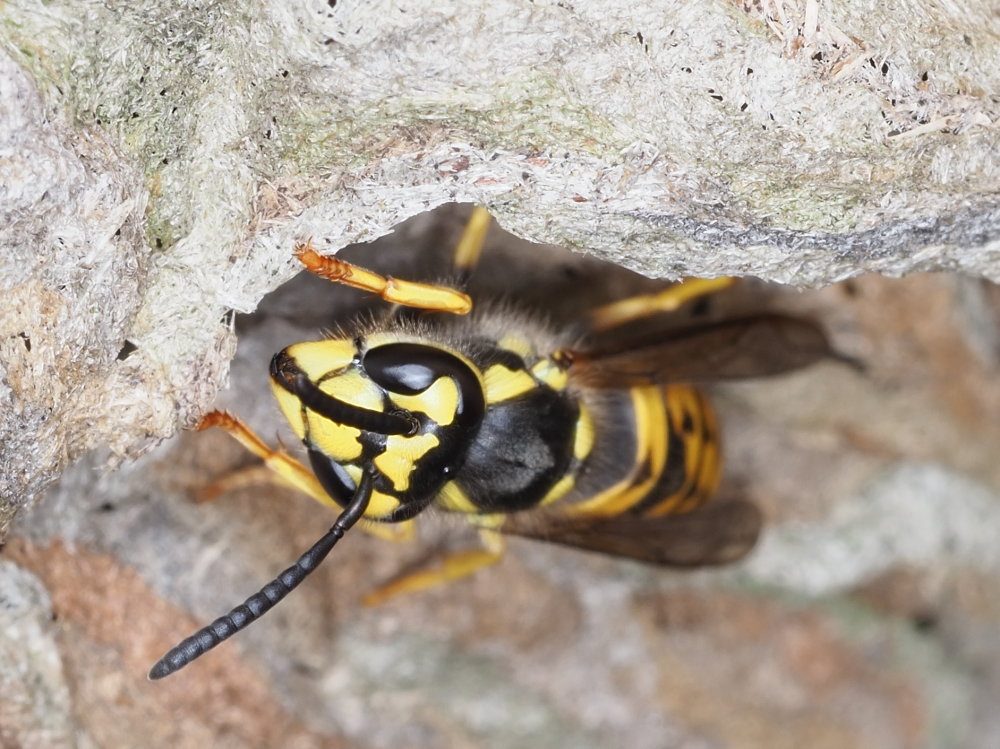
[563,314,835,387]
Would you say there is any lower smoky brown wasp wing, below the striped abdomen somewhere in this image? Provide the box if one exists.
[500,500,762,567]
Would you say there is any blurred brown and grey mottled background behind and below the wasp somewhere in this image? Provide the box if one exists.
[0,206,1000,749]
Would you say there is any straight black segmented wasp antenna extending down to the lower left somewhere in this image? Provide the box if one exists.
[149,469,372,680]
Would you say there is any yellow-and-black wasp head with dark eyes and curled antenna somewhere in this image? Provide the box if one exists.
[271,335,485,520]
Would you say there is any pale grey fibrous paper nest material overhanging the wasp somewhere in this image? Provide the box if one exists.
[0,0,1000,531]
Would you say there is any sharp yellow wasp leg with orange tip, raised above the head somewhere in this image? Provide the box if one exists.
[295,242,472,315]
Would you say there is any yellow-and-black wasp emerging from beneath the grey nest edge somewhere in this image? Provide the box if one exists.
[149,208,831,679]
